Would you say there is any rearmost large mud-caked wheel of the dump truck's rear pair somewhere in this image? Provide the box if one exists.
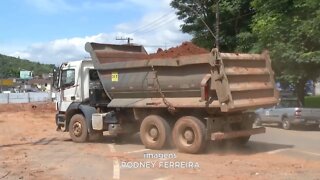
[172,116,206,154]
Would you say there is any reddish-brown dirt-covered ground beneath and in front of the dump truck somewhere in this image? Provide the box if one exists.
[0,104,320,180]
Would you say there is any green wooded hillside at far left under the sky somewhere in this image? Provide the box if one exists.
[0,54,54,78]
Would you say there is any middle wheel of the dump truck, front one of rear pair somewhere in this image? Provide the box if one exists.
[140,115,171,149]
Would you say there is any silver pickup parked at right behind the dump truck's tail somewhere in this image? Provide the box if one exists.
[255,98,320,130]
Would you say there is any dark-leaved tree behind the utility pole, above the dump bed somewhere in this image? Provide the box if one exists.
[171,0,255,52]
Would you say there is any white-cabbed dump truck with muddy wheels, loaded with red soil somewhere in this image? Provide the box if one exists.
[56,43,278,153]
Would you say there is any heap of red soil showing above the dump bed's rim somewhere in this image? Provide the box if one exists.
[148,42,209,59]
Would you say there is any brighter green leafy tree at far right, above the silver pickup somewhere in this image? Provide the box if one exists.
[251,0,320,105]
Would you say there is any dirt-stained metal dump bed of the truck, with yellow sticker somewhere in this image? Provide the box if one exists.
[86,43,278,112]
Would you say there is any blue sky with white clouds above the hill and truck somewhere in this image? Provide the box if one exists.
[0,0,190,64]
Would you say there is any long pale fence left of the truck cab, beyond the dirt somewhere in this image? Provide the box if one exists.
[0,92,52,104]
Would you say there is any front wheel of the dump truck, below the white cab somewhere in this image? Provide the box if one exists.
[69,114,88,142]
